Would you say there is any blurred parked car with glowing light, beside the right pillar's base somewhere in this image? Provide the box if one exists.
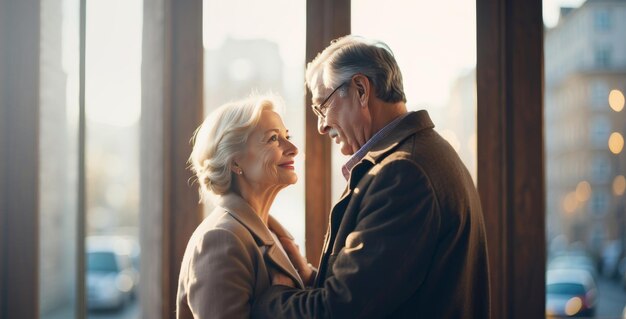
[546,269,598,317]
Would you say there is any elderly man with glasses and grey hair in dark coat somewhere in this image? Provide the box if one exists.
[252,36,489,318]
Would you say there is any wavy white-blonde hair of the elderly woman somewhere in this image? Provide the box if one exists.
[188,94,284,200]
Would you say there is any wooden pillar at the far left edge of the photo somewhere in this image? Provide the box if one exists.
[0,0,40,319]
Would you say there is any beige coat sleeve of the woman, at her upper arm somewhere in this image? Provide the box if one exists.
[186,229,255,318]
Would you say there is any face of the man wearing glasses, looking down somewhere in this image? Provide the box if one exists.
[312,75,370,155]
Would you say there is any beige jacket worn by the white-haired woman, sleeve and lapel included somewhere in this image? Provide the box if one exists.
[176,194,303,319]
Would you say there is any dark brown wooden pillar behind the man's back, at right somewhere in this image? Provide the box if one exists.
[476,0,546,319]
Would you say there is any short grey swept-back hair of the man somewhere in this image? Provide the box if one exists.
[306,35,406,103]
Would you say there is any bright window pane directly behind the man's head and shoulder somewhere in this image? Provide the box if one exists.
[344,0,476,201]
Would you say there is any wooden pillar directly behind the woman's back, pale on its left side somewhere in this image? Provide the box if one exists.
[140,0,204,318]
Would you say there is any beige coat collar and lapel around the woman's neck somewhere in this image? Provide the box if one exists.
[216,193,304,289]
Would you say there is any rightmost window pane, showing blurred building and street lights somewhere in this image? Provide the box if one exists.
[543,0,626,318]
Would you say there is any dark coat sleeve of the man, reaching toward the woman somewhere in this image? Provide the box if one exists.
[252,159,441,318]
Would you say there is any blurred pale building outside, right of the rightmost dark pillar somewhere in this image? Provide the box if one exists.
[544,0,626,262]
